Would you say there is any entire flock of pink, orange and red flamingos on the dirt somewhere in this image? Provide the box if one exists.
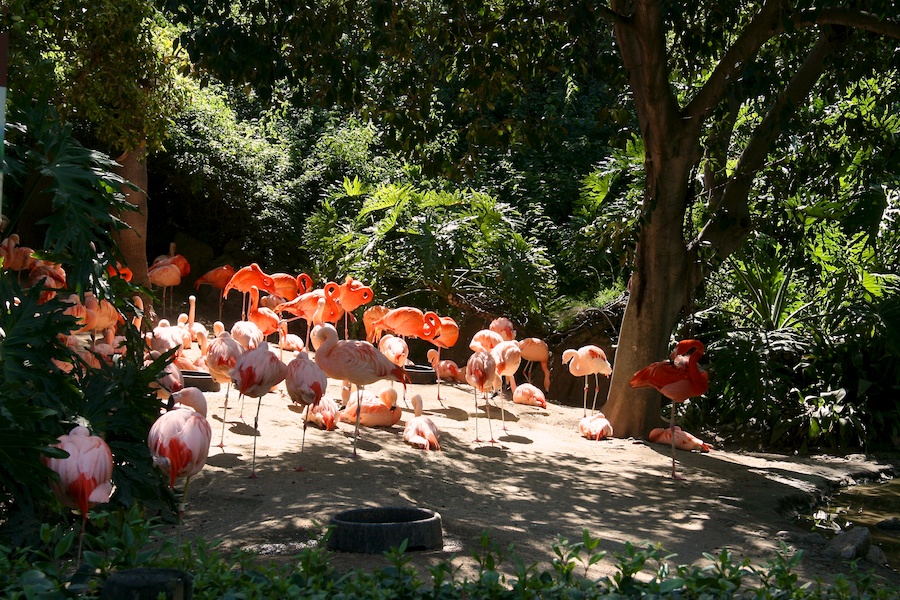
[7,235,710,531]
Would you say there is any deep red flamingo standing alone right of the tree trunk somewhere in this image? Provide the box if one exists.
[629,340,709,479]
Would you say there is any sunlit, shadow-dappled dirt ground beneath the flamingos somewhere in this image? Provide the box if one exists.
[174,338,898,581]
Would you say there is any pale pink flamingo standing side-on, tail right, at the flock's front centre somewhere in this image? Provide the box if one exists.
[312,323,409,456]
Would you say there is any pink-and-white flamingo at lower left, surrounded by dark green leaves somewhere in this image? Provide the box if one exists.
[41,425,113,565]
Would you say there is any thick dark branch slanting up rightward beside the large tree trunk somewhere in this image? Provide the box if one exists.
[695,27,846,259]
